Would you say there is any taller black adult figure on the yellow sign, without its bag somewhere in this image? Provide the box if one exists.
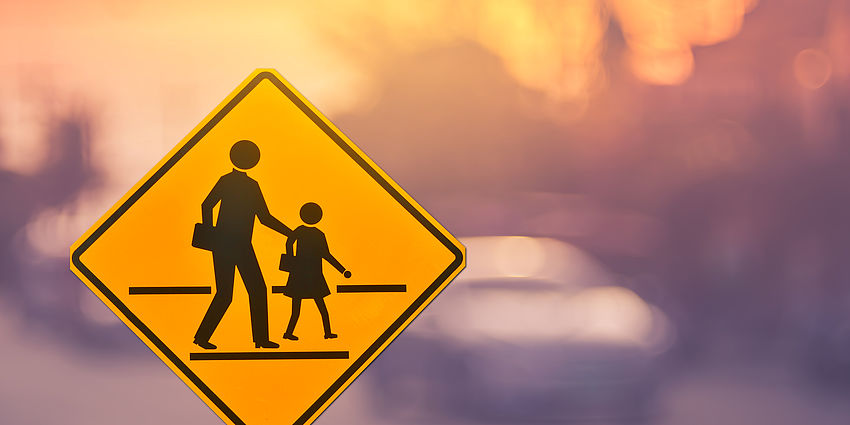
[194,140,292,350]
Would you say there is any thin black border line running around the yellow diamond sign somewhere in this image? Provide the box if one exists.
[71,71,463,425]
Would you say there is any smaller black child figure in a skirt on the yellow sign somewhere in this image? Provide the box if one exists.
[283,202,344,341]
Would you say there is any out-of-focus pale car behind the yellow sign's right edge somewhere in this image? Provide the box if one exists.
[370,237,673,423]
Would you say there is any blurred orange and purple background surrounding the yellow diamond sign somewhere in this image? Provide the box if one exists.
[0,0,850,425]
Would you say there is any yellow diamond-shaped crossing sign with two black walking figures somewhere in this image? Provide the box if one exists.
[71,70,465,425]
